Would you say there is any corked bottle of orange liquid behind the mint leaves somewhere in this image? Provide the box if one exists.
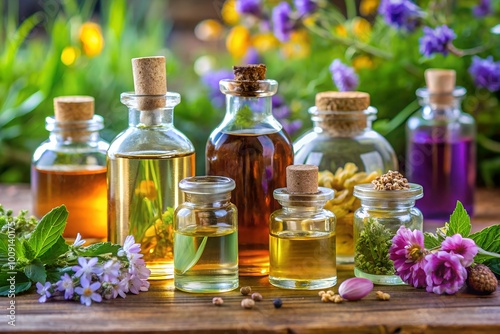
[31,96,109,243]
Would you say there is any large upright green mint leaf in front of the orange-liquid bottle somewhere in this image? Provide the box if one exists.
[29,205,68,257]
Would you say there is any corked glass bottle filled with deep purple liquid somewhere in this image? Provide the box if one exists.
[405,69,476,221]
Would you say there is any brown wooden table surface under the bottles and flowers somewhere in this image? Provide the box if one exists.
[0,185,500,333]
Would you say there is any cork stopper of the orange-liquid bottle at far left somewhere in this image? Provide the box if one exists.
[54,96,94,122]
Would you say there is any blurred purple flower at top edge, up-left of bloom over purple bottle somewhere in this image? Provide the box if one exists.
[378,0,422,31]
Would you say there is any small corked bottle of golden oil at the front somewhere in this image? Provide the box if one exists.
[269,165,337,290]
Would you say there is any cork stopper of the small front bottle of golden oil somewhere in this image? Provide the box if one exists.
[286,165,318,194]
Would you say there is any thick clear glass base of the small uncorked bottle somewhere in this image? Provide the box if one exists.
[174,276,239,293]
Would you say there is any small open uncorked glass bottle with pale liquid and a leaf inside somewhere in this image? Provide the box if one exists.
[174,176,239,293]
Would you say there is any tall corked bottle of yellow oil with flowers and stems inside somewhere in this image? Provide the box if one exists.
[108,57,195,279]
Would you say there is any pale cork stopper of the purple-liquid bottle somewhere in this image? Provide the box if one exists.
[424,68,456,104]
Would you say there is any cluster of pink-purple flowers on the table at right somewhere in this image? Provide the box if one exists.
[389,226,478,294]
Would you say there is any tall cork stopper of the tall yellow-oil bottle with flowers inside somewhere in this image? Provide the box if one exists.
[132,56,167,110]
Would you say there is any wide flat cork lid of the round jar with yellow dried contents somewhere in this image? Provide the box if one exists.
[316,91,370,111]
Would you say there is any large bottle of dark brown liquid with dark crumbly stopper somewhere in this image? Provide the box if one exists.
[206,65,293,276]
